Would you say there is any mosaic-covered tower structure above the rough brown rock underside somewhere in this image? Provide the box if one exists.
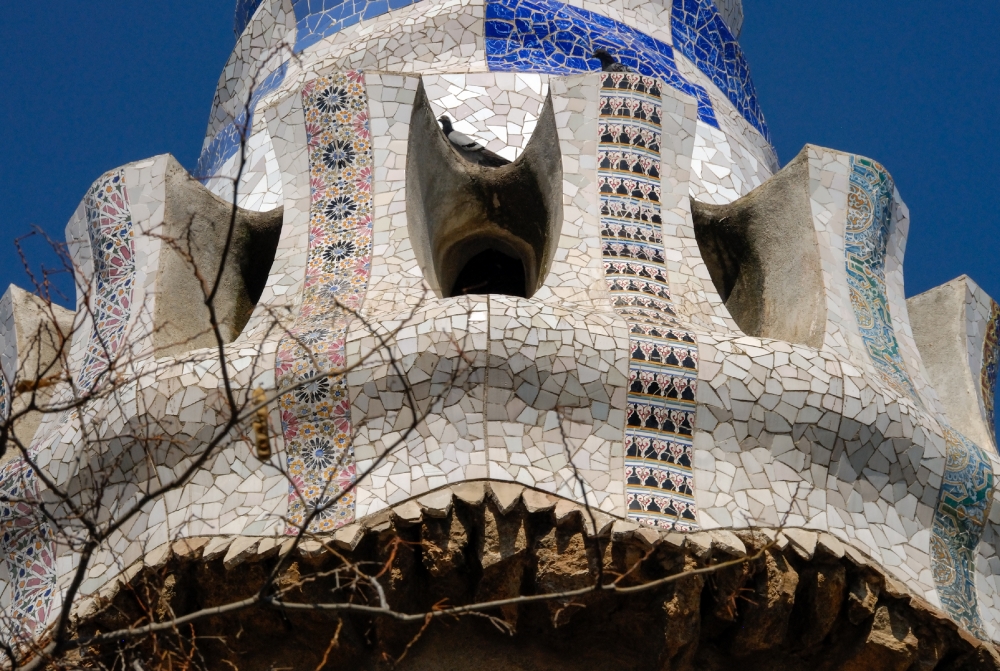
[0,0,1000,652]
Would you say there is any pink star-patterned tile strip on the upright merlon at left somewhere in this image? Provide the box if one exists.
[78,169,135,389]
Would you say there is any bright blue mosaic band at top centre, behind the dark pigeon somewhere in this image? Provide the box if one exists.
[486,0,719,128]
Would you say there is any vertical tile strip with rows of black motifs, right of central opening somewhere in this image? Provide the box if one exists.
[597,73,698,530]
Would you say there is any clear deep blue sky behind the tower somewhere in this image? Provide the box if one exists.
[0,0,1000,304]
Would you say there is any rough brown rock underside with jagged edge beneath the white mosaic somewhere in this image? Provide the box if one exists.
[77,482,1000,671]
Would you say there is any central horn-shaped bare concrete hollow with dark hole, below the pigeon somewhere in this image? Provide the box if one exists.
[406,78,563,298]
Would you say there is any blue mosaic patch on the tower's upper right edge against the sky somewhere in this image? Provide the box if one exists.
[671,0,771,142]
